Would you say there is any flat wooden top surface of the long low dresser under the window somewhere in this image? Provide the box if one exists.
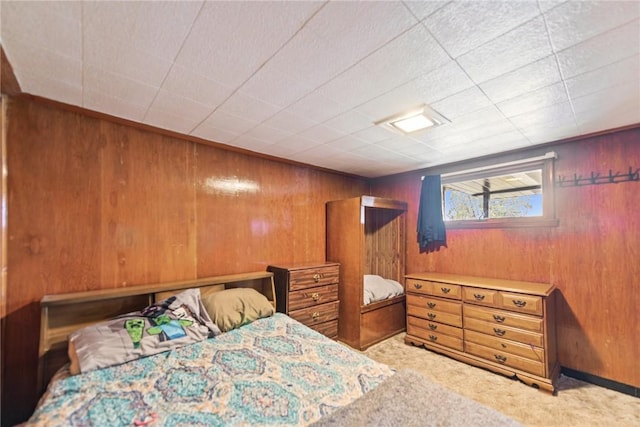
[405,272,555,296]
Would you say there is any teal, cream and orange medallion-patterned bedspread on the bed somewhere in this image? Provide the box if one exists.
[27,313,393,427]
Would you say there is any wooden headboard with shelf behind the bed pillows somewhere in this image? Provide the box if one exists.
[38,271,276,392]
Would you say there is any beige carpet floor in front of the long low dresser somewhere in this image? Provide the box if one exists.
[364,334,640,427]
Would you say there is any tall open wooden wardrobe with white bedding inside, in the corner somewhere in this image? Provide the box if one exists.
[327,196,407,350]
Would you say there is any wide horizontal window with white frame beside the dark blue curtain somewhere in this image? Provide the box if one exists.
[442,153,557,228]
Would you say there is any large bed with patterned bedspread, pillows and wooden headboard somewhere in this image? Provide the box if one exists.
[25,272,517,426]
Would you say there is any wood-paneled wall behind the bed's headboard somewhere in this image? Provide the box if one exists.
[2,97,369,425]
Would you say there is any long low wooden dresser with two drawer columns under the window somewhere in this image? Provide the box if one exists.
[405,273,560,394]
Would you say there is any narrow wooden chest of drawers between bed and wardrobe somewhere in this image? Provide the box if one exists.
[267,262,340,339]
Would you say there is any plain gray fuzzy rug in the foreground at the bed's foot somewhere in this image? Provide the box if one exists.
[312,369,521,427]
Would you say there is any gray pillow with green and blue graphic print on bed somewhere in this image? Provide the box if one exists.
[69,289,220,374]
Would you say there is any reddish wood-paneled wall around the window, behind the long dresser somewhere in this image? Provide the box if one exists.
[372,128,640,387]
